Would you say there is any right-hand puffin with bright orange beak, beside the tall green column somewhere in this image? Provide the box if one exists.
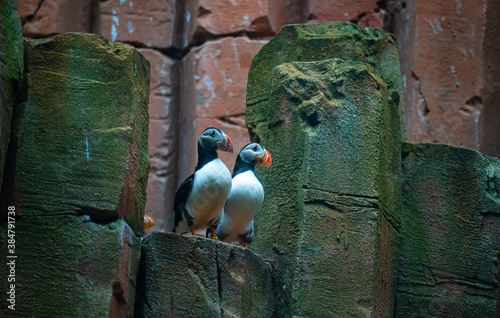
[216,143,272,248]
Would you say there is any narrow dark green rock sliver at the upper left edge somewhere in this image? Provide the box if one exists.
[0,0,23,194]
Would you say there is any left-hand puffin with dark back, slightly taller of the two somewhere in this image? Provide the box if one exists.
[172,127,233,239]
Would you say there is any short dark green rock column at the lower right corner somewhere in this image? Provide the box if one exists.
[395,144,500,317]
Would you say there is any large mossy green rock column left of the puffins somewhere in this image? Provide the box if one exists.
[0,34,149,317]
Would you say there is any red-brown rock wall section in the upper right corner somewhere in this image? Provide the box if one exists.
[394,0,500,156]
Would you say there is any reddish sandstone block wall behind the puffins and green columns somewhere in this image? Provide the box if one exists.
[18,0,500,231]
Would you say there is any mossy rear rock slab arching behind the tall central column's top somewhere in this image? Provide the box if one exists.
[246,22,406,142]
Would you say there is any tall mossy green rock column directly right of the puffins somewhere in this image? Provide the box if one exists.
[247,23,403,317]
